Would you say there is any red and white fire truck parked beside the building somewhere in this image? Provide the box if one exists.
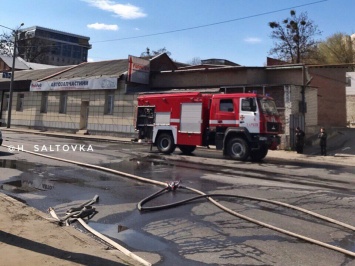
[136,92,282,161]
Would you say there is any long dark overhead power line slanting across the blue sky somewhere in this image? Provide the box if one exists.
[92,0,328,43]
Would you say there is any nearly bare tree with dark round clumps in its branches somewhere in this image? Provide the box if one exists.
[269,10,321,63]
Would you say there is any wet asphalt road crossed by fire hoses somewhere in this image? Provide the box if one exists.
[0,132,355,265]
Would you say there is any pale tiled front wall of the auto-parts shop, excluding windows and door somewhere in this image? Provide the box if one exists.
[2,80,136,136]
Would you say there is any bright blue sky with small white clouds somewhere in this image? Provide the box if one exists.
[0,0,355,66]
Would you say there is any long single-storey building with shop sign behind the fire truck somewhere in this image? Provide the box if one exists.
[0,54,349,148]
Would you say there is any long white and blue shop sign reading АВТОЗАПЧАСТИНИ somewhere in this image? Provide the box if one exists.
[30,78,117,91]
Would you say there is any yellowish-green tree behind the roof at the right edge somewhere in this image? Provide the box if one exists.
[313,32,355,64]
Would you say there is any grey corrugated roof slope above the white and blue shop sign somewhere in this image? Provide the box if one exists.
[40,59,128,80]
